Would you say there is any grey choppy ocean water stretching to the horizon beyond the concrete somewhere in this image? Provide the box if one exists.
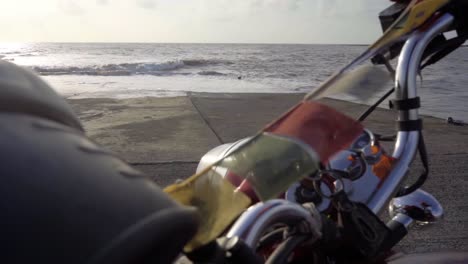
[0,43,468,121]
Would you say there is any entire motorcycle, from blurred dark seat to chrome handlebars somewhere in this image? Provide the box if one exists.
[0,0,468,264]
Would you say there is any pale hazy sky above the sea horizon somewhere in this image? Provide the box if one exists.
[0,0,391,44]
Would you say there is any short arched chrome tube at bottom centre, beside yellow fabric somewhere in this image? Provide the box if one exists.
[226,199,321,248]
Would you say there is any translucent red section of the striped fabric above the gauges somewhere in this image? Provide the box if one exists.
[264,101,363,162]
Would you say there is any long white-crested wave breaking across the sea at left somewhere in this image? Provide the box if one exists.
[31,59,231,76]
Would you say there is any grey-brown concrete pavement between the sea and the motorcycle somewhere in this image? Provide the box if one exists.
[69,93,468,252]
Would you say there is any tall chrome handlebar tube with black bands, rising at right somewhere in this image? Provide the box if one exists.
[368,14,454,214]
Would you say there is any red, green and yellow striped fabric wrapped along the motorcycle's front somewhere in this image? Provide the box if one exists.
[165,101,363,251]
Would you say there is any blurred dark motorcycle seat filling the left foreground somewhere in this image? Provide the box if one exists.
[0,62,198,264]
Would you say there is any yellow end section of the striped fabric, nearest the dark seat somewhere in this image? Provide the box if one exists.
[164,166,251,252]
